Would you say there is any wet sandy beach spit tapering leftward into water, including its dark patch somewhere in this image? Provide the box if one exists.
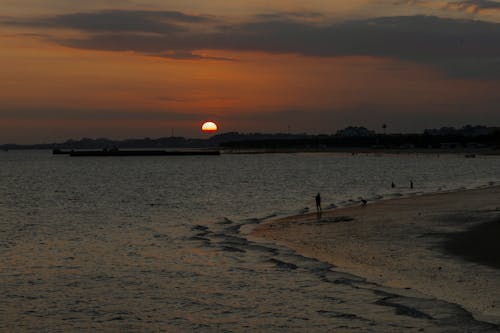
[252,187,500,324]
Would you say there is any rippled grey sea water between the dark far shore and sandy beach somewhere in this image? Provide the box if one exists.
[0,151,500,332]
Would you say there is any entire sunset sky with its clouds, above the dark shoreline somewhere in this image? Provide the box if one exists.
[0,0,500,143]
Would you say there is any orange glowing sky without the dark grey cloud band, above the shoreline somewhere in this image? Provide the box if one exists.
[0,0,500,143]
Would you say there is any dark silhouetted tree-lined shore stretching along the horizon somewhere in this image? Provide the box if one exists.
[0,125,500,153]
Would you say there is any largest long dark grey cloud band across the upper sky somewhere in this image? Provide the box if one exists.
[4,9,500,78]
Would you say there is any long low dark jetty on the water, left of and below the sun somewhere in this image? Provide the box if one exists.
[52,148,220,157]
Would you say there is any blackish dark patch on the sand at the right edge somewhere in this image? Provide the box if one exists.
[445,220,500,269]
